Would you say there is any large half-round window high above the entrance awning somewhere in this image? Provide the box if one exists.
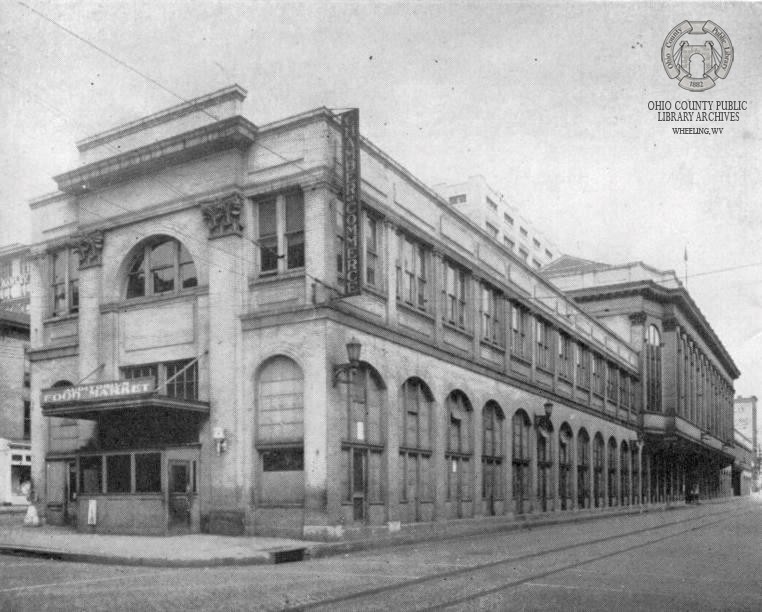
[127,236,198,298]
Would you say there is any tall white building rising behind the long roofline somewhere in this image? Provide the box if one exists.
[434,175,561,270]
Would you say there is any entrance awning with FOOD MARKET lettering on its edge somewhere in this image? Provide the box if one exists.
[41,378,209,420]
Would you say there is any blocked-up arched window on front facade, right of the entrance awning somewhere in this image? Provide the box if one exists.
[256,356,304,504]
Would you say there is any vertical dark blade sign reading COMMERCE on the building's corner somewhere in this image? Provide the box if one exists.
[341,108,362,296]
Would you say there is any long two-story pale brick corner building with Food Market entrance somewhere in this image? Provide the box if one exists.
[31,86,652,539]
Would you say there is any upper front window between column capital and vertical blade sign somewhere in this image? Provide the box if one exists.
[257,191,304,275]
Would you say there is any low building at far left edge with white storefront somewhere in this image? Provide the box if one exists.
[0,310,32,505]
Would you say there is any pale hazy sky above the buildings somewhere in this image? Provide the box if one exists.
[0,0,762,396]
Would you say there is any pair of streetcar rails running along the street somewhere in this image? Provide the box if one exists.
[284,509,754,612]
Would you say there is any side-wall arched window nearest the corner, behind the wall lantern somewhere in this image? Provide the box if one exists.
[341,364,385,523]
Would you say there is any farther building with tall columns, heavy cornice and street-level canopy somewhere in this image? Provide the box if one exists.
[543,255,740,497]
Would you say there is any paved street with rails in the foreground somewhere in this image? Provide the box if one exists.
[0,498,762,610]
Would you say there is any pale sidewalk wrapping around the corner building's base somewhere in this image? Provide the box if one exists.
[0,498,749,567]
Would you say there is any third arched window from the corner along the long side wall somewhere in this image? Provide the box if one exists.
[445,390,473,517]
